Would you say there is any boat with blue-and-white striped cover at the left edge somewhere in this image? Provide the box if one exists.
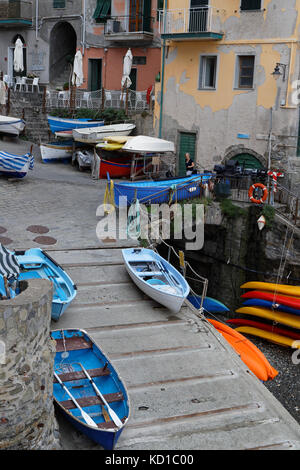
[0,151,34,178]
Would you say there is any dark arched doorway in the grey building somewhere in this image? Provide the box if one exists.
[49,21,77,85]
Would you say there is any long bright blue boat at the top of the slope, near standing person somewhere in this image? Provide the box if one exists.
[114,173,212,207]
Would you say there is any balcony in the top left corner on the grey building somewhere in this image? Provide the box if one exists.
[0,0,32,28]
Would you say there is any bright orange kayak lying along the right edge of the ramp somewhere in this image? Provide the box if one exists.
[208,319,278,381]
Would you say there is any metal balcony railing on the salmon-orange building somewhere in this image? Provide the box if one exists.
[104,15,156,35]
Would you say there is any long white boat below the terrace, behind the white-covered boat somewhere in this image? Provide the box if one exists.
[73,123,135,144]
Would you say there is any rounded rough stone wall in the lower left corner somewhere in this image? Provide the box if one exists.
[0,279,59,450]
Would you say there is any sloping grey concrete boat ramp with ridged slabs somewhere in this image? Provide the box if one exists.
[50,249,300,450]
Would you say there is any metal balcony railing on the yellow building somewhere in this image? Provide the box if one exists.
[159,6,214,34]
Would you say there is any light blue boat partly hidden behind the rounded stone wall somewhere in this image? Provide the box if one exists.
[15,248,77,321]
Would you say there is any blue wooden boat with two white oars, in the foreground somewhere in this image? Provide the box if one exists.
[51,329,130,450]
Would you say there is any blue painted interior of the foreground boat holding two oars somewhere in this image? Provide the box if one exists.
[51,330,129,430]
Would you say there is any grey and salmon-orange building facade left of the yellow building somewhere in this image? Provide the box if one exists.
[0,0,161,91]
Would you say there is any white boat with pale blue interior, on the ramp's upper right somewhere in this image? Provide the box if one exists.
[122,248,190,313]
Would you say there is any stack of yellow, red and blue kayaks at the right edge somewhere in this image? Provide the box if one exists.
[228,282,300,349]
